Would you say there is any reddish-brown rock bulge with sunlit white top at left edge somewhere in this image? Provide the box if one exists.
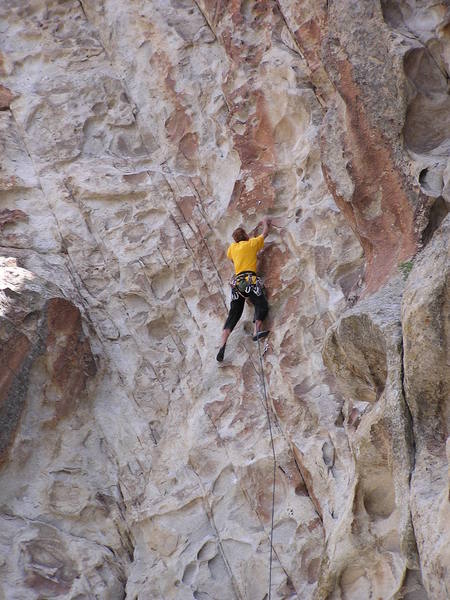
[0,259,96,459]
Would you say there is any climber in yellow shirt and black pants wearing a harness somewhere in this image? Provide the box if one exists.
[216,217,270,362]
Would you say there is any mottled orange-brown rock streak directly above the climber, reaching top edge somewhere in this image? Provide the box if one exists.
[202,0,275,215]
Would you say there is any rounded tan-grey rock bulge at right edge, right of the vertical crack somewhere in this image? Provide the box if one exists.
[402,217,450,598]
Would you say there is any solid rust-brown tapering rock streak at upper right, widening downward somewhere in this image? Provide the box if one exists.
[323,61,418,293]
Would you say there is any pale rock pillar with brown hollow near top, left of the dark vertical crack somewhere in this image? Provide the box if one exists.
[318,277,423,599]
